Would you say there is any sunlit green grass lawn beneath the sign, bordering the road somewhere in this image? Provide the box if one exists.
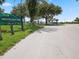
[0,24,41,55]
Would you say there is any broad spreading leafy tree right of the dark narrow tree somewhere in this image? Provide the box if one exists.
[38,2,62,24]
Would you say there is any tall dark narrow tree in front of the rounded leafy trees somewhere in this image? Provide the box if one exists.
[28,0,37,23]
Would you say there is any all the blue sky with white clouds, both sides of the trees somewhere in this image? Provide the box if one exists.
[1,0,79,21]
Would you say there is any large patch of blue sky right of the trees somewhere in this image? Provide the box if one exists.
[49,0,79,21]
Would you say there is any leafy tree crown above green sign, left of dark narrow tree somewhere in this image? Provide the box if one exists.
[11,4,27,17]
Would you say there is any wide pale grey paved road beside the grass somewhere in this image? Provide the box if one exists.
[0,25,79,59]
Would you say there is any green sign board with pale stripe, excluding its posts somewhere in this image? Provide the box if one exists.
[0,13,21,25]
